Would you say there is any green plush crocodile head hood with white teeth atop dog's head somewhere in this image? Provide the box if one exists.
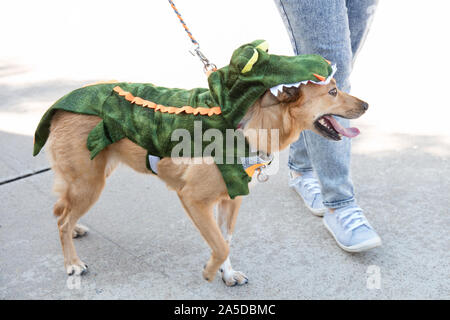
[208,40,359,140]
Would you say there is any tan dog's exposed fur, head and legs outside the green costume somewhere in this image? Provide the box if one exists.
[48,80,368,286]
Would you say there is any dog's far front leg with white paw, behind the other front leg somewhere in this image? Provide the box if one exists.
[217,197,248,286]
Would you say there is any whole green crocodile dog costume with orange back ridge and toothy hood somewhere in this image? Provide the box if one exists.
[33,40,335,198]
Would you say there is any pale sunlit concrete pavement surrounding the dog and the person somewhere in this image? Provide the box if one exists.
[0,0,450,299]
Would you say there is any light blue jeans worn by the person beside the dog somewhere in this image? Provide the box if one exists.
[275,0,377,208]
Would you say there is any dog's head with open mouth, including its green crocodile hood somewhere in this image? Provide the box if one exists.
[208,40,368,140]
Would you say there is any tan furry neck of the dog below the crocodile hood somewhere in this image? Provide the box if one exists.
[240,99,302,154]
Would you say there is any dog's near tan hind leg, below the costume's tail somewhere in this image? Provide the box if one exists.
[48,112,108,275]
